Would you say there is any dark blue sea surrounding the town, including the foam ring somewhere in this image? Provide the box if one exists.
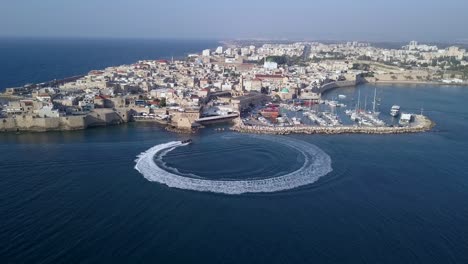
[0,39,468,263]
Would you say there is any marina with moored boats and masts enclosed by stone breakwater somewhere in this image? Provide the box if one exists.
[236,85,435,134]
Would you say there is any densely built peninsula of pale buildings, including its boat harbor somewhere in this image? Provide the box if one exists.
[0,41,468,134]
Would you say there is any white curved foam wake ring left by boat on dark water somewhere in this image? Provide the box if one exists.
[135,137,332,194]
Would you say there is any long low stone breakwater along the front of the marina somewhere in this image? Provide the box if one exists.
[231,115,435,135]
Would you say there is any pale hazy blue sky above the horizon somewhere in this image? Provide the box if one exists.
[0,0,468,41]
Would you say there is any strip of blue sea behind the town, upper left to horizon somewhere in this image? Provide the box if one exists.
[0,38,218,91]
